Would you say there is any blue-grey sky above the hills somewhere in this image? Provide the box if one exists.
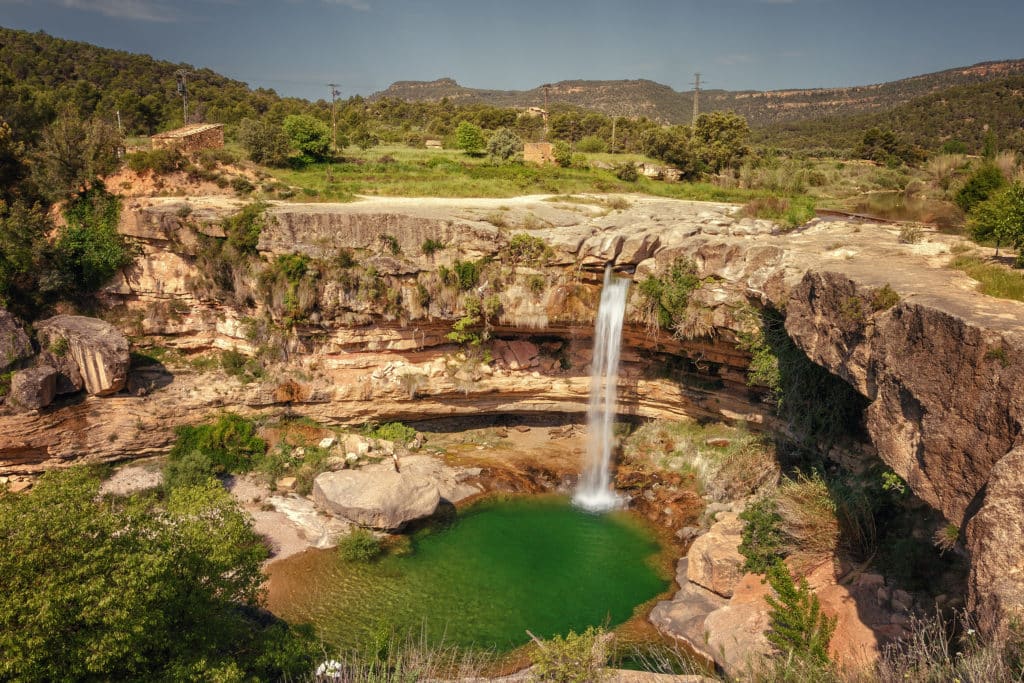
[0,0,1024,98]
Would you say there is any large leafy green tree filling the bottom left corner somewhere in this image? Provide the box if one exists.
[0,468,313,681]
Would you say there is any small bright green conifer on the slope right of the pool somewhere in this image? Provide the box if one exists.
[765,562,836,665]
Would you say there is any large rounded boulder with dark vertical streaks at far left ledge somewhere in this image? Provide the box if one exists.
[36,315,129,396]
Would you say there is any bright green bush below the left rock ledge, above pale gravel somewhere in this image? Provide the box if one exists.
[168,413,266,474]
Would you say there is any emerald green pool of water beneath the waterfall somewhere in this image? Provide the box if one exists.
[271,498,669,651]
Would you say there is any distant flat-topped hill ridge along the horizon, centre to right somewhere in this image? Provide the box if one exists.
[369,59,1024,127]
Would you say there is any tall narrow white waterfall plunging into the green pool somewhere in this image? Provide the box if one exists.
[572,265,630,512]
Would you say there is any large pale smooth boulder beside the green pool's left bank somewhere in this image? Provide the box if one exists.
[313,470,441,530]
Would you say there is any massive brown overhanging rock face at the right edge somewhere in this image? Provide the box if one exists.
[785,272,1024,624]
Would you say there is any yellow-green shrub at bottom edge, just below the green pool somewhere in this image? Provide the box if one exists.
[530,627,608,683]
